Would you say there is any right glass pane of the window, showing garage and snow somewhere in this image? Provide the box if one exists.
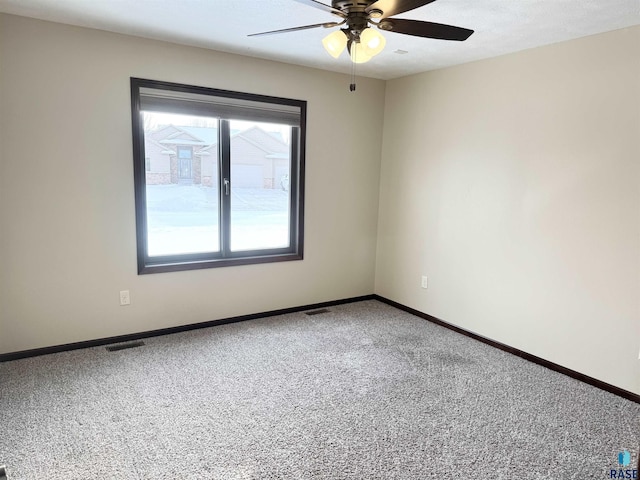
[230,121,291,251]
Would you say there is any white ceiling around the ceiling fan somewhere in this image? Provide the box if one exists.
[0,0,640,79]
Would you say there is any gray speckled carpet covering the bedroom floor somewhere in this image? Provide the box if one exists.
[0,301,640,480]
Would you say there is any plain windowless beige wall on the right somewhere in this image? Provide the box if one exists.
[375,27,640,393]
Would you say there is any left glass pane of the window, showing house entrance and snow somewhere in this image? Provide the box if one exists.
[143,112,220,256]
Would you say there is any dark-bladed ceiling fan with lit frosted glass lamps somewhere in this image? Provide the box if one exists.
[249,0,473,63]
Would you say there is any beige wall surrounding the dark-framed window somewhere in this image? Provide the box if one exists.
[0,15,385,353]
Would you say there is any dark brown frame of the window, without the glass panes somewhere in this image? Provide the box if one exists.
[131,77,307,274]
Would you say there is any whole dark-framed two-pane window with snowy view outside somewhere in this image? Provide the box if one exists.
[131,78,306,274]
